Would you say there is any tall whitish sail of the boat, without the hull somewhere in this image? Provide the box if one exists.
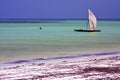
[88,9,97,30]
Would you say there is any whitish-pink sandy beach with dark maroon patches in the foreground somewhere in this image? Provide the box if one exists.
[0,51,120,80]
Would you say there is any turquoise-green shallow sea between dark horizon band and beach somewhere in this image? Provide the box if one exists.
[0,20,120,60]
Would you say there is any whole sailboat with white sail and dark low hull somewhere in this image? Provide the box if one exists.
[74,9,101,32]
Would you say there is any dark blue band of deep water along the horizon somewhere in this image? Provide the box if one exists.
[0,18,120,23]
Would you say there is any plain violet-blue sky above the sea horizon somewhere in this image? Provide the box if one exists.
[0,0,120,19]
